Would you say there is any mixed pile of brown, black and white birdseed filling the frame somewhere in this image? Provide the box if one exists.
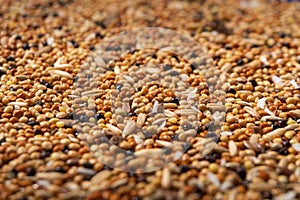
[0,0,300,199]
